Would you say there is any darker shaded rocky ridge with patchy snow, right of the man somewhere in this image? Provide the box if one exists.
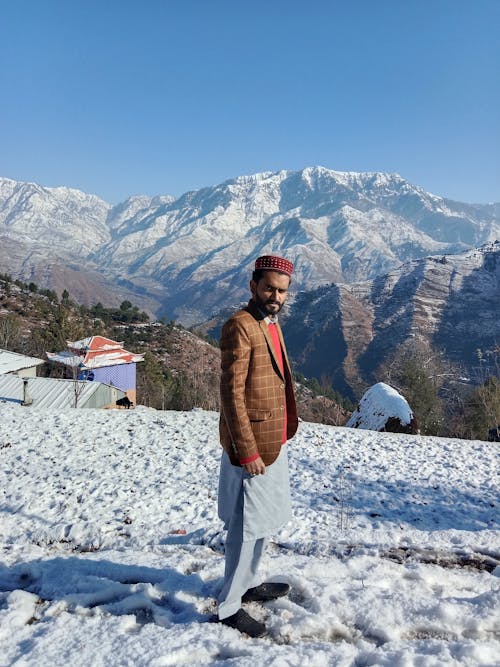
[284,241,500,391]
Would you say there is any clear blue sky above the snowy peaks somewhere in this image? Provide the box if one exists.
[0,0,500,203]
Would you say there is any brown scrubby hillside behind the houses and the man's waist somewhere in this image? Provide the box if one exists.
[0,274,349,425]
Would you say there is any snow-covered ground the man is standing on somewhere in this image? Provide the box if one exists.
[0,403,500,667]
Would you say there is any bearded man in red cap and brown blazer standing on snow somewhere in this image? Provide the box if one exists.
[218,255,298,637]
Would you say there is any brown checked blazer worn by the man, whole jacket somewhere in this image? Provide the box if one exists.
[219,301,298,466]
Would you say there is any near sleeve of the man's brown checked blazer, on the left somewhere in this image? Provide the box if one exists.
[220,320,259,462]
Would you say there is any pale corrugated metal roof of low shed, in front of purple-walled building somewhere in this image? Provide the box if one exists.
[0,375,125,408]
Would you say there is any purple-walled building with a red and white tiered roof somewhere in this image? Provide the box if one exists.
[47,336,144,405]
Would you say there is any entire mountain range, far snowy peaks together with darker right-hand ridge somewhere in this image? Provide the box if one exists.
[0,167,500,393]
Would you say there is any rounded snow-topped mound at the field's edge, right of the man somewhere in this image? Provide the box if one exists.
[346,382,417,433]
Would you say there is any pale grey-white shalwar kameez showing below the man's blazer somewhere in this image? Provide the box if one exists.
[218,444,291,619]
